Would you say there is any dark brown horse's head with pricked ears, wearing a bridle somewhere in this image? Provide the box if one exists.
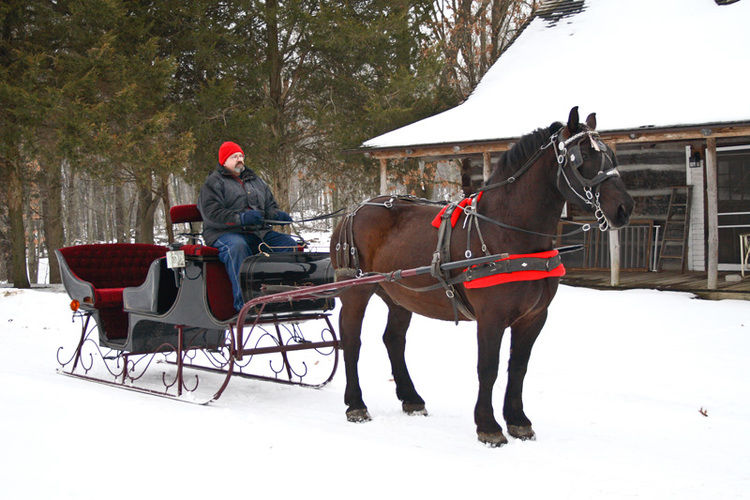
[552,106,634,229]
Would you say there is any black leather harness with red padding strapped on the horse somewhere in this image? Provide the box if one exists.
[335,128,620,323]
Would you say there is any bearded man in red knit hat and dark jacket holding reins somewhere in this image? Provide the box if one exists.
[198,142,297,311]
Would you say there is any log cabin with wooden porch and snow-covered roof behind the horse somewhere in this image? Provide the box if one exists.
[362,0,750,289]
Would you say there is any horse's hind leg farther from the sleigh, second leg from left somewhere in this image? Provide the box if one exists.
[378,293,427,415]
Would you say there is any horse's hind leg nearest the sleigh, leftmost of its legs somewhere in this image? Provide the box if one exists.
[339,286,374,422]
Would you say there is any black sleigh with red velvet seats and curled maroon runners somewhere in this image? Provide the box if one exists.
[56,205,339,403]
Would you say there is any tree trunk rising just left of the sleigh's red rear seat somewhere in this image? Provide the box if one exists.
[40,165,65,283]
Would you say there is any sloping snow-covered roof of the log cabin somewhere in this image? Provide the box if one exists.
[362,0,750,148]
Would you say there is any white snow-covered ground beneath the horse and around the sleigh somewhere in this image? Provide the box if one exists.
[0,286,750,499]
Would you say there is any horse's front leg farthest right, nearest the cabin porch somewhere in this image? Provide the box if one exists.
[503,309,547,439]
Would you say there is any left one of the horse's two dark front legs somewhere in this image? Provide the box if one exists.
[474,318,508,446]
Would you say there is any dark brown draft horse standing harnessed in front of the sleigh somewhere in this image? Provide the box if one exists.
[331,107,634,447]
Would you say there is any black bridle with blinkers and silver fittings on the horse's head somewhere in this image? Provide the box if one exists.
[542,129,620,231]
